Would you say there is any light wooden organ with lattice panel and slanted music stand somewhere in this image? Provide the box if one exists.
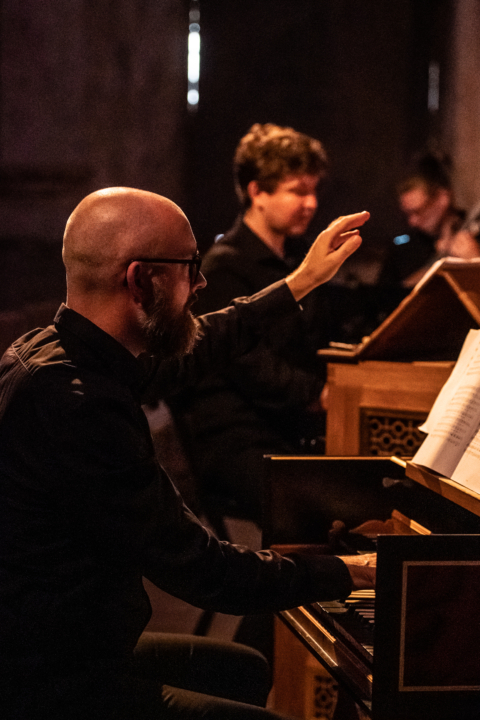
[319,258,480,457]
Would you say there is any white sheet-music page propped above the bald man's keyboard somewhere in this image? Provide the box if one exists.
[413,330,480,484]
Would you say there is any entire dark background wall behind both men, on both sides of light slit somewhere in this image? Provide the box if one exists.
[0,0,462,349]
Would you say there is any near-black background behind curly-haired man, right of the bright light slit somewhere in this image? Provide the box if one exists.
[187,0,449,249]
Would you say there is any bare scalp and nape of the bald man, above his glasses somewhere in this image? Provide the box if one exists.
[63,187,193,296]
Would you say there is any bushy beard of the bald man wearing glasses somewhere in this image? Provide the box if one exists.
[142,289,201,360]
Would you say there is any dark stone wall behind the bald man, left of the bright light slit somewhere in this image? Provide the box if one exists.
[0,0,188,349]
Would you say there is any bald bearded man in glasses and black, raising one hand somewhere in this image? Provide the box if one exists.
[0,188,374,720]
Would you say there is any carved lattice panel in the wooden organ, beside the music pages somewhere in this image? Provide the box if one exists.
[360,408,426,457]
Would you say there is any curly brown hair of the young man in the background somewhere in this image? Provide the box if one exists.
[233,123,328,209]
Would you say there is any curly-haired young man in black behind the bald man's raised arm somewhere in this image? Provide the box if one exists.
[170,124,332,522]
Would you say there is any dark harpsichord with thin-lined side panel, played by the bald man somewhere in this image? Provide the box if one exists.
[264,456,480,720]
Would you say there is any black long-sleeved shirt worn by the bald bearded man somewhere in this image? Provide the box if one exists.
[0,283,350,718]
